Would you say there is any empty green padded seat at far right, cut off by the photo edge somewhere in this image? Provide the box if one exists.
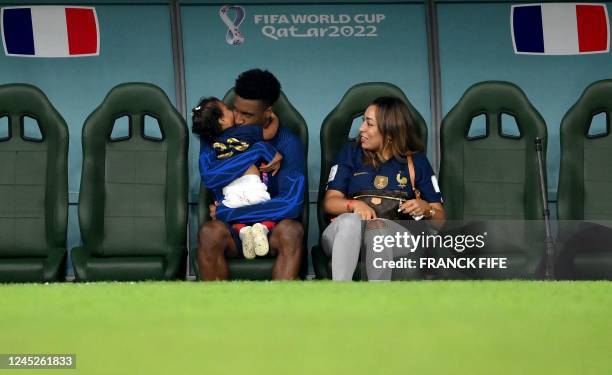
[556,79,612,279]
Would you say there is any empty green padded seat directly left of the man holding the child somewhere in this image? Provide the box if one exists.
[71,83,188,281]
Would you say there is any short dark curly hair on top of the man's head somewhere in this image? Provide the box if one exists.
[234,69,281,107]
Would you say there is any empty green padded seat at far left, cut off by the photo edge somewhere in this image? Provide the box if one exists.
[0,84,68,282]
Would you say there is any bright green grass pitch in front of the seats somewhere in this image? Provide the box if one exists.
[0,281,612,375]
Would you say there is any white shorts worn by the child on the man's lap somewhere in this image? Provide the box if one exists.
[223,174,270,208]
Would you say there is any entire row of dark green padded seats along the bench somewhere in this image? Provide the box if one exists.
[0,80,612,282]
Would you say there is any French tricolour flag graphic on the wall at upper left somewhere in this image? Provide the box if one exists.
[0,5,100,57]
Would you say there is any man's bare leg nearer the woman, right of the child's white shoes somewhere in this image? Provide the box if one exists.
[270,219,304,280]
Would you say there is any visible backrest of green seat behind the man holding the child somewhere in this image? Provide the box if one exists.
[198,89,308,231]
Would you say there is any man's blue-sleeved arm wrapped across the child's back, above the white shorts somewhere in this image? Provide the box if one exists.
[200,142,276,189]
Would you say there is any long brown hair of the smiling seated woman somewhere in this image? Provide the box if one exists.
[363,96,424,169]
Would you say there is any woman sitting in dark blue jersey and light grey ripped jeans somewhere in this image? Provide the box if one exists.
[322,97,445,280]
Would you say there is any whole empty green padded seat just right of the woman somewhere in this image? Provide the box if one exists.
[437,81,547,279]
